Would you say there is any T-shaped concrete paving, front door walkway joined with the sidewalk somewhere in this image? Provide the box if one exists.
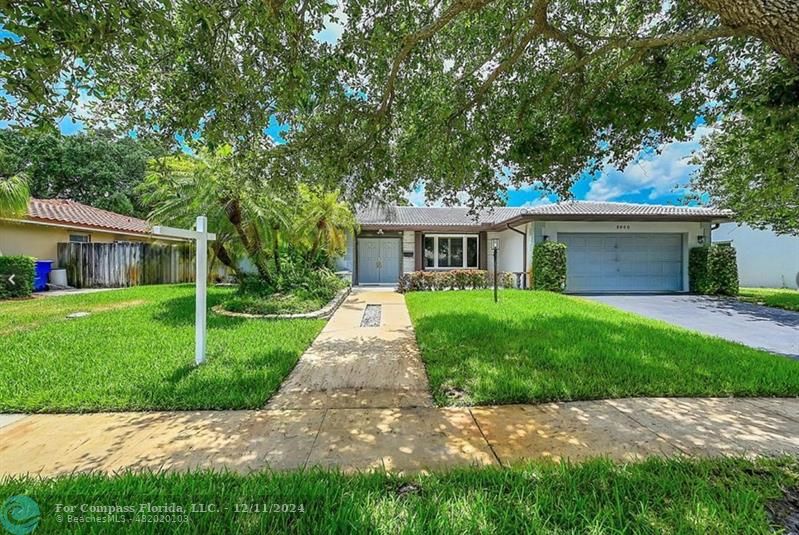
[0,291,799,476]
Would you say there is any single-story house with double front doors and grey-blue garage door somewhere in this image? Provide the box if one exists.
[338,201,729,292]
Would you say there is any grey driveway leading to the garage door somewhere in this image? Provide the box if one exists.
[582,295,799,358]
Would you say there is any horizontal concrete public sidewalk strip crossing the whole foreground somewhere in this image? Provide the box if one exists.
[0,398,799,476]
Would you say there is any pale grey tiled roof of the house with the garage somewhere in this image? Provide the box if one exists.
[356,201,731,229]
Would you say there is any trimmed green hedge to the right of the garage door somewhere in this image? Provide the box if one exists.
[688,245,738,295]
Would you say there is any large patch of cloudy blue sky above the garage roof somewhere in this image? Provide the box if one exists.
[585,127,711,201]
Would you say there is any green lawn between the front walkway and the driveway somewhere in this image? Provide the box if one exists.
[406,290,799,405]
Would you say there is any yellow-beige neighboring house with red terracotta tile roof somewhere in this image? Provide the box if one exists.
[0,199,178,261]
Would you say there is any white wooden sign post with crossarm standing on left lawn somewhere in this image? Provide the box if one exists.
[153,215,216,365]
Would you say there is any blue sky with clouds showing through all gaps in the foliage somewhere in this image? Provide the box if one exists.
[0,9,710,206]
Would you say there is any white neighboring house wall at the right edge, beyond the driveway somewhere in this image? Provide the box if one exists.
[713,223,799,288]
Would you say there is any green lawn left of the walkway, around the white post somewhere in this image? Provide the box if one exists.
[0,285,324,412]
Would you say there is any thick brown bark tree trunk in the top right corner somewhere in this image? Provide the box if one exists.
[697,0,799,67]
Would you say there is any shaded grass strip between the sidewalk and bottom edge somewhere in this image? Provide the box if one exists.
[0,459,799,534]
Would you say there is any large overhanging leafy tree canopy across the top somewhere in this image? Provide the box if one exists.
[0,0,799,228]
